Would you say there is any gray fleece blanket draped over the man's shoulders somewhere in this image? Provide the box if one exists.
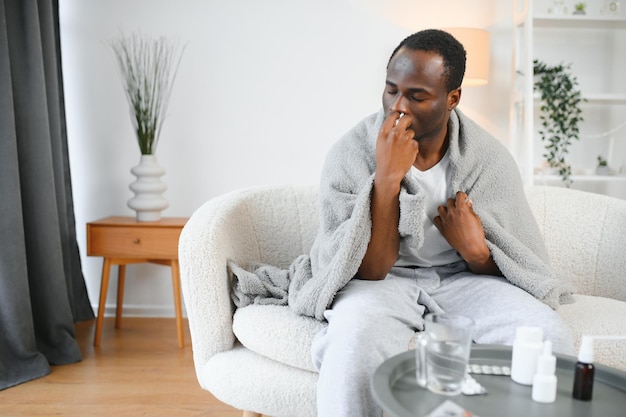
[229,109,572,320]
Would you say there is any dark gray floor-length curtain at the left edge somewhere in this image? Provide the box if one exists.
[0,0,94,389]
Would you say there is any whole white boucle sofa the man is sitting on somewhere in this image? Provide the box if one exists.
[179,185,626,417]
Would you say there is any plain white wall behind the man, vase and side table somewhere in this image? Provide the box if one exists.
[60,0,512,316]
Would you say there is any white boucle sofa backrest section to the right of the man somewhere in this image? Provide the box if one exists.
[526,186,626,301]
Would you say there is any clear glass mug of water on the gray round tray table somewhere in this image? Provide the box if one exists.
[415,313,474,395]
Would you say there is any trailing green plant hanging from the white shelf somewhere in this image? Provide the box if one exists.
[533,59,584,187]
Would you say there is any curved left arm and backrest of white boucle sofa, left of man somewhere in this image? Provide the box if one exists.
[178,185,318,375]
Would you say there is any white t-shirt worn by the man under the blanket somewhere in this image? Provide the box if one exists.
[395,152,462,267]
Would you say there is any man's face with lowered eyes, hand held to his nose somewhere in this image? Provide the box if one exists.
[383,48,460,141]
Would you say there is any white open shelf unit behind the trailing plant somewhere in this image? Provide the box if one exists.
[510,0,626,198]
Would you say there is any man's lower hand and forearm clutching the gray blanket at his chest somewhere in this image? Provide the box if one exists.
[433,191,502,275]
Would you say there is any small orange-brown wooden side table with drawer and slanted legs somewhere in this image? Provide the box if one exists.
[87,216,188,348]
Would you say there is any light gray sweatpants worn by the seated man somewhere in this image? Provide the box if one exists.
[311,268,575,417]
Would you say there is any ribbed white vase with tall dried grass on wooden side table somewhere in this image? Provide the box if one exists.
[109,34,184,222]
